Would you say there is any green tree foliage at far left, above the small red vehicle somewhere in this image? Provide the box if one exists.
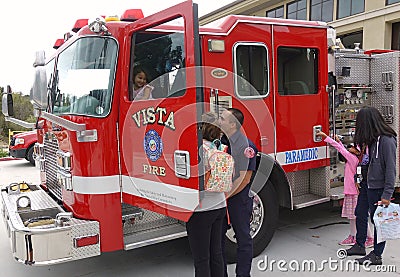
[0,87,36,141]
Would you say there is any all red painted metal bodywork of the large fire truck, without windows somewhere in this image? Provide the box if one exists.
[38,1,329,251]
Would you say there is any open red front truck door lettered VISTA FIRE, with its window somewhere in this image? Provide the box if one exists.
[119,1,202,221]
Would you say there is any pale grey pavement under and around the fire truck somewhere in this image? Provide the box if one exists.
[0,160,400,277]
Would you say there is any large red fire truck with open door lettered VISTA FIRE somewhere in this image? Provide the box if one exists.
[1,1,399,265]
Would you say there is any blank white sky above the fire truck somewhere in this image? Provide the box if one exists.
[0,0,233,94]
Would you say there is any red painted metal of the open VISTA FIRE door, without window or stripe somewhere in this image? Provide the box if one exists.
[119,1,199,220]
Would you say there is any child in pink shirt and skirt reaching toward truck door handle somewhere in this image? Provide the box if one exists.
[317,132,374,247]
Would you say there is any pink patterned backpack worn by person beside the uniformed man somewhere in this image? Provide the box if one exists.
[203,140,235,192]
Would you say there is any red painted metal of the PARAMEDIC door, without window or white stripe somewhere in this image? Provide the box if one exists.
[274,26,329,172]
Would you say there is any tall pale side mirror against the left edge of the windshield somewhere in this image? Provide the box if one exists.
[30,51,47,110]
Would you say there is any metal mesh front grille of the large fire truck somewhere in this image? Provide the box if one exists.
[44,133,62,200]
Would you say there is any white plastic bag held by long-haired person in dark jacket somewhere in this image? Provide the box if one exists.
[374,203,400,243]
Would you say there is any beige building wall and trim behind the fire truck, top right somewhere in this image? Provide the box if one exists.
[200,0,400,50]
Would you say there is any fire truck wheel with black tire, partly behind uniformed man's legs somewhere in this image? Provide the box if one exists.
[225,181,279,263]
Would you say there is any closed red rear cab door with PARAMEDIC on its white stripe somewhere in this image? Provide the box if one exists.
[273,26,329,171]
